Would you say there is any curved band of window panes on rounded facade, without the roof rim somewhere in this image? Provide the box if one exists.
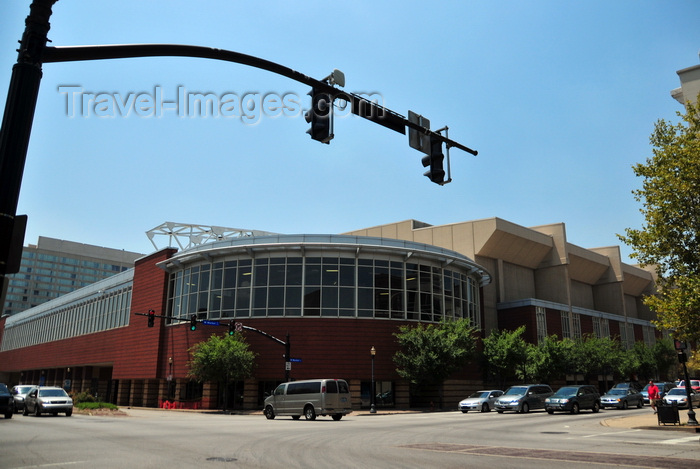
[168,252,481,327]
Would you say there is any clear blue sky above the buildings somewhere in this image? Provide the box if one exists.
[0,0,700,262]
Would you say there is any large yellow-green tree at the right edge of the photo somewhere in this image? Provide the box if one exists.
[620,96,700,340]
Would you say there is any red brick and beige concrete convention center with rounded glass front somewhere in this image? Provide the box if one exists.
[0,218,660,409]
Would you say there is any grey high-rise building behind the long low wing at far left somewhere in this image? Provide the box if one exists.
[3,236,143,316]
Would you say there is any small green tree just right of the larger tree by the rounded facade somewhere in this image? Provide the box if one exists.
[483,326,528,386]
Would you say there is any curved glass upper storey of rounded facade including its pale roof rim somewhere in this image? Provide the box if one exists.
[161,236,488,327]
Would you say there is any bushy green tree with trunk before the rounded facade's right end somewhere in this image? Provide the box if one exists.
[394,319,477,407]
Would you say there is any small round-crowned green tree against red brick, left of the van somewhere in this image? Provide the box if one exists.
[187,332,256,410]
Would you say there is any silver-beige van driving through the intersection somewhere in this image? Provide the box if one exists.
[263,379,352,420]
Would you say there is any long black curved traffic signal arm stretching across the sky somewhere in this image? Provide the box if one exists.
[42,44,477,156]
